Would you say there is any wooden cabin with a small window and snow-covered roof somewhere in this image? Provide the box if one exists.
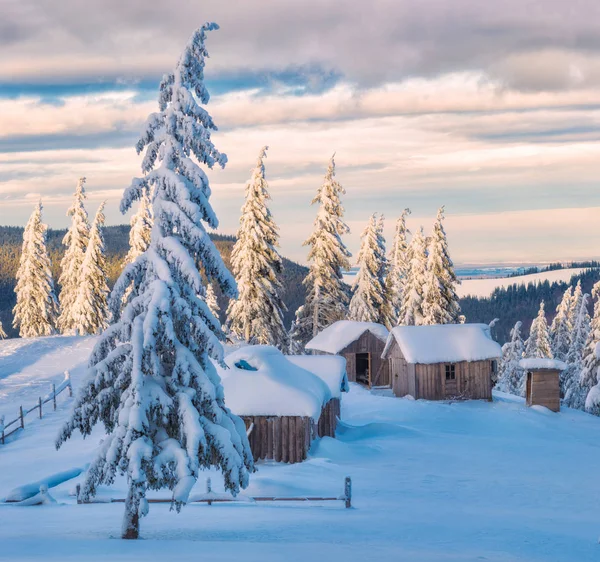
[383,324,502,400]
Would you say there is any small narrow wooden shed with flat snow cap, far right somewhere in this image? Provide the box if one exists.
[519,358,567,412]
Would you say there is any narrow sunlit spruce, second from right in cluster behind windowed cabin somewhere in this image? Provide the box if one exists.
[400,227,427,326]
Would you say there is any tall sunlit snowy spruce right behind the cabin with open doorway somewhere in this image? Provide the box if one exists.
[290,155,351,346]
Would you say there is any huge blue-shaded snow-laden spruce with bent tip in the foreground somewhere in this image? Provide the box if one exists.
[57,24,253,539]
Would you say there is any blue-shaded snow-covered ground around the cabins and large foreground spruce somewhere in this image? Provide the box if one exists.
[0,338,600,562]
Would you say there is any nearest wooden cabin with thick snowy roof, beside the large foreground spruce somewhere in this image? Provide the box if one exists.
[217,345,347,463]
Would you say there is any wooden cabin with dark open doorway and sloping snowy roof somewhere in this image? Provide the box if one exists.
[305,320,390,388]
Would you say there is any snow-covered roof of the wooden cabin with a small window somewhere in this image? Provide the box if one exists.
[383,324,502,365]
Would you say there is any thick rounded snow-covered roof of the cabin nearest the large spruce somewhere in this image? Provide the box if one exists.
[217,345,331,421]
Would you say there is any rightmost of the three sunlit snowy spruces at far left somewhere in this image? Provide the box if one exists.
[73,203,109,335]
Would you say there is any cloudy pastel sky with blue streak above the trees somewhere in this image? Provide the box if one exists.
[0,0,600,264]
